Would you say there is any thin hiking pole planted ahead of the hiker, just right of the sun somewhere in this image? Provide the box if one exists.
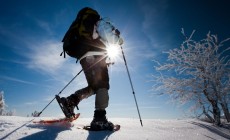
[120,45,143,127]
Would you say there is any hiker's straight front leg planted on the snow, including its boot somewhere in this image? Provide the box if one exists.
[86,57,113,130]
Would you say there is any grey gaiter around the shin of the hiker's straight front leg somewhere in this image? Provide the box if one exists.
[95,88,109,110]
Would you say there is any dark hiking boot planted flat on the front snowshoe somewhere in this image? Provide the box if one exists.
[90,110,114,131]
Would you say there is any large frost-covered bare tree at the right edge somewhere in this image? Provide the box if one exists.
[154,30,230,125]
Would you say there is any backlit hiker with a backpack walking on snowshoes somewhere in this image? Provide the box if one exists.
[61,7,123,130]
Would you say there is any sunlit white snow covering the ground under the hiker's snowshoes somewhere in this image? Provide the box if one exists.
[0,116,230,140]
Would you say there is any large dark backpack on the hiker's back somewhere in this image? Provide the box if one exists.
[61,7,100,60]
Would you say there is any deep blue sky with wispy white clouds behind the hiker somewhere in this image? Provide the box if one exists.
[0,0,230,119]
